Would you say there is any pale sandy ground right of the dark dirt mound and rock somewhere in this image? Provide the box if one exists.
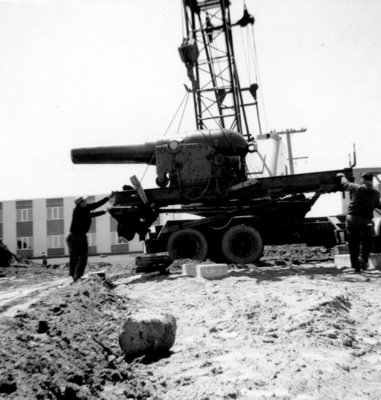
[110,263,381,400]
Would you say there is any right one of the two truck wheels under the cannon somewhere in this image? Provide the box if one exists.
[221,224,263,264]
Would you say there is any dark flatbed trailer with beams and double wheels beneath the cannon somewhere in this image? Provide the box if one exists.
[109,168,352,263]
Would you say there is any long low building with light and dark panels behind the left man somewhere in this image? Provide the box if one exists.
[0,195,143,258]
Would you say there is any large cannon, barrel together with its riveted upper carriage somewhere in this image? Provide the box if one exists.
[71,129,255,189]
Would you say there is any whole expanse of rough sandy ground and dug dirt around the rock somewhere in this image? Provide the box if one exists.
[0,252,381,400]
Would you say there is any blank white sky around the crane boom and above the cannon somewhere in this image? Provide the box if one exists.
[0,0,381,216]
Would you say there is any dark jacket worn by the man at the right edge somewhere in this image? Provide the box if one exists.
[343,182,380,219]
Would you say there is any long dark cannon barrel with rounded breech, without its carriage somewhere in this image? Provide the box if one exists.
[71,129,249,165]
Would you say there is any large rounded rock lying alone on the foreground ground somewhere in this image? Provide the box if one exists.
[119,312,176,359]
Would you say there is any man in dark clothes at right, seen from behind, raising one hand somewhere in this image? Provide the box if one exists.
[337,172,380,273]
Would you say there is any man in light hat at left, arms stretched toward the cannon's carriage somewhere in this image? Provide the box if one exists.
[66,193,114,282]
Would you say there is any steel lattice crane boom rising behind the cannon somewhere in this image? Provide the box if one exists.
[179,0,261,142]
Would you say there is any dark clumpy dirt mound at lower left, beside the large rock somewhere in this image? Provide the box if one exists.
[0,276,155,400]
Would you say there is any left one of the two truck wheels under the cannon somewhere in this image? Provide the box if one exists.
[167,228,208,261]
